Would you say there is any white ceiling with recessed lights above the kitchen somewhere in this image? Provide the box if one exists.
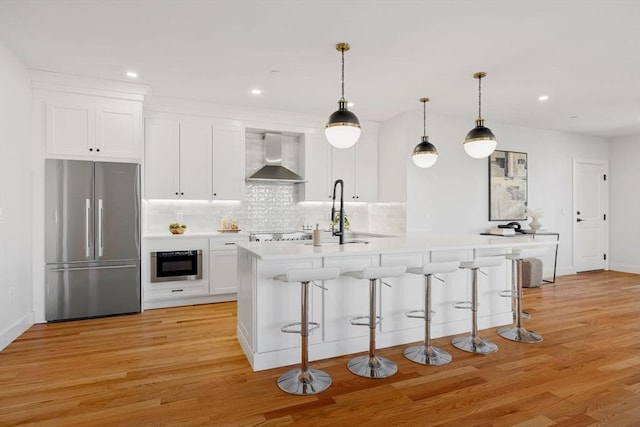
[0,0,640,137]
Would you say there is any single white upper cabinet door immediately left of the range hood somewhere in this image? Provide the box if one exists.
[210,126,244,200]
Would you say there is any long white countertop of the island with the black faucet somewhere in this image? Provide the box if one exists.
[237,232,557,260]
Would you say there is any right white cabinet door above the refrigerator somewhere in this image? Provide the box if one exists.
[95,100,142,159]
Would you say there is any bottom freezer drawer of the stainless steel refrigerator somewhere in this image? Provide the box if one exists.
[45,260,140,322]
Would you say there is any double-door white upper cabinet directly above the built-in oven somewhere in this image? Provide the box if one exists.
[145,118,211,200]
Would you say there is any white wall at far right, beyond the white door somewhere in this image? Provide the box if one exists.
[609,134,640,273]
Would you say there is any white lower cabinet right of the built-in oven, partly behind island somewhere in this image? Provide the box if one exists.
[209,235,249,299]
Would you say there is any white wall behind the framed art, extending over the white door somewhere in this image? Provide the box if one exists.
[380,110,609,274]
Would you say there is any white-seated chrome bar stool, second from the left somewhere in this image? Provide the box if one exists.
[342,265,407,378]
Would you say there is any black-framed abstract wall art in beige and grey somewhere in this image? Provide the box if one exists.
[489,150,528,221]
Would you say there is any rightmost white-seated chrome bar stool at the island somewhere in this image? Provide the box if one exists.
[498,248,547,343]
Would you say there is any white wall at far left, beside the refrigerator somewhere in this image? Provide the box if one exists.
[0,42,34,350]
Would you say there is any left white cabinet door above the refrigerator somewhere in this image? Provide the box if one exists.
[47,96,95,156]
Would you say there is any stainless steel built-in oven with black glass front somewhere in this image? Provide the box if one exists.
[151,249,202,283]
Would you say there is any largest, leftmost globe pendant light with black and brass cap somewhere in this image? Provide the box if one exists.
[324,43,361,148]
